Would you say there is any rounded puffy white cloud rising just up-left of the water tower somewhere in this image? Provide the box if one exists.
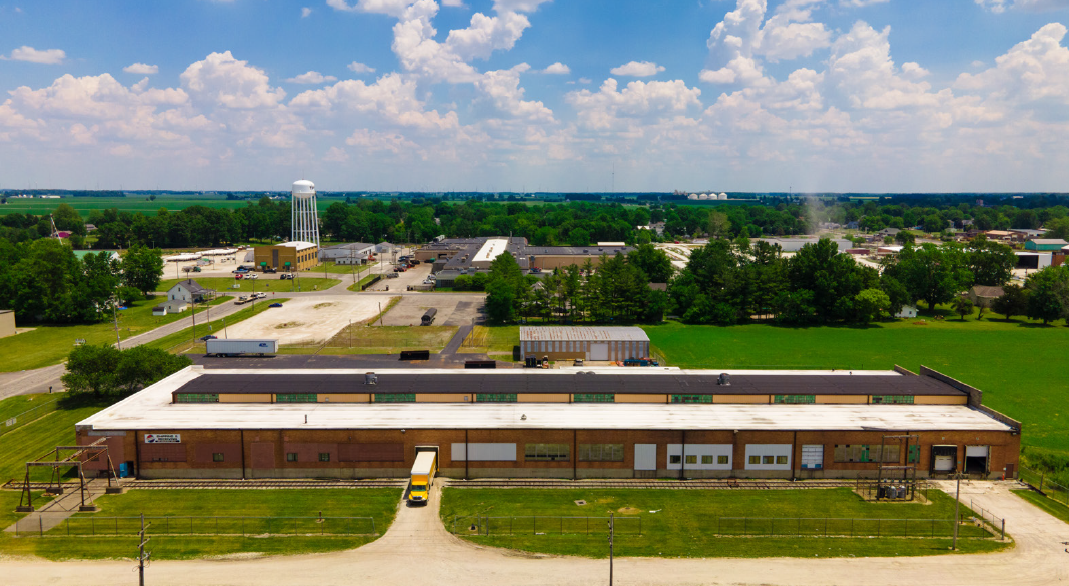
[180,51,285,109]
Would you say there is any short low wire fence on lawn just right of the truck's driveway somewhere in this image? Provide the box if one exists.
[452,515,642,537]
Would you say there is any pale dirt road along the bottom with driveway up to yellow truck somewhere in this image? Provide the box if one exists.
[0,482,1069,586]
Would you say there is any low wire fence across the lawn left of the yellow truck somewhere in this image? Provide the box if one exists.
[15,514,378,537]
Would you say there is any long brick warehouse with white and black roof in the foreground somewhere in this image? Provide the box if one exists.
[76,366,1021,478]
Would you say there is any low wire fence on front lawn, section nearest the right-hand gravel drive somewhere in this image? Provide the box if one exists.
[716,516,991,538]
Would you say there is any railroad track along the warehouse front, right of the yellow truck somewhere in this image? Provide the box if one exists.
[445,479,856,490]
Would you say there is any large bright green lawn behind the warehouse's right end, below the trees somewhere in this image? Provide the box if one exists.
[644,318,1069,454]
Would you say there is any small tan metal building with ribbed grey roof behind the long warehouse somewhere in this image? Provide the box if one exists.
[520,326,650,361]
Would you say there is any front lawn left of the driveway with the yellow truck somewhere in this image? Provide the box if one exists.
[0,489,401,559]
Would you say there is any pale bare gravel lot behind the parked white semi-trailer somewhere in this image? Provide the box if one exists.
[216,295,380,344]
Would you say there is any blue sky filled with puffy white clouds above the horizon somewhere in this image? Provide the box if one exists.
[0,0,1069,192]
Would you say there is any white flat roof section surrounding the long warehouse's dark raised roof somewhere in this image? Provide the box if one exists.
[77,368,1011,431]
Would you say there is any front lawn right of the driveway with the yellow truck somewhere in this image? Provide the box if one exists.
[441,489,1007,557]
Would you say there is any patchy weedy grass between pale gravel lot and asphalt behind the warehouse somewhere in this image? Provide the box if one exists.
[320,324,458,354]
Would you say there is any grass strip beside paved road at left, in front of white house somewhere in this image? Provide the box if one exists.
[0,296,232,372]
